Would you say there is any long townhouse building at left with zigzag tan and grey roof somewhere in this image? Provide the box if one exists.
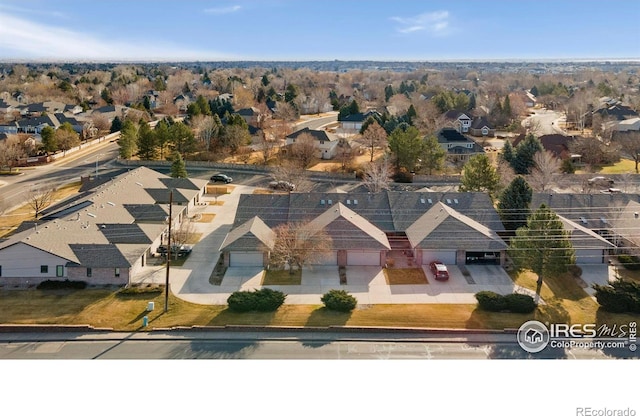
[0,167,207,285]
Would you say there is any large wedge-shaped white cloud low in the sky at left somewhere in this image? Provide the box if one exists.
[0,11,228,61]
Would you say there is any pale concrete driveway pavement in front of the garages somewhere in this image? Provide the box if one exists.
[129,185,614,305]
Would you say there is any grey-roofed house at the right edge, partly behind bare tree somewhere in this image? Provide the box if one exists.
[531,193,640,264]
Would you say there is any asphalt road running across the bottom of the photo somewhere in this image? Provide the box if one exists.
[0,331,638,360]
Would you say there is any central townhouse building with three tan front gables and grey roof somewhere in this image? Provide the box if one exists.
[221,191,507,267]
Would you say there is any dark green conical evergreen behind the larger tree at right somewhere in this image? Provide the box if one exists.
[498,175,533,231]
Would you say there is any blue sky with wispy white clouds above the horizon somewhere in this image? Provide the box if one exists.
[0,0,640,61]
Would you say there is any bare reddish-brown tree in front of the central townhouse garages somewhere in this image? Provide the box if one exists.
[269,223,333,274]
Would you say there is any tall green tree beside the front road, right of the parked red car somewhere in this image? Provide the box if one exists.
[509,204,575,303]
